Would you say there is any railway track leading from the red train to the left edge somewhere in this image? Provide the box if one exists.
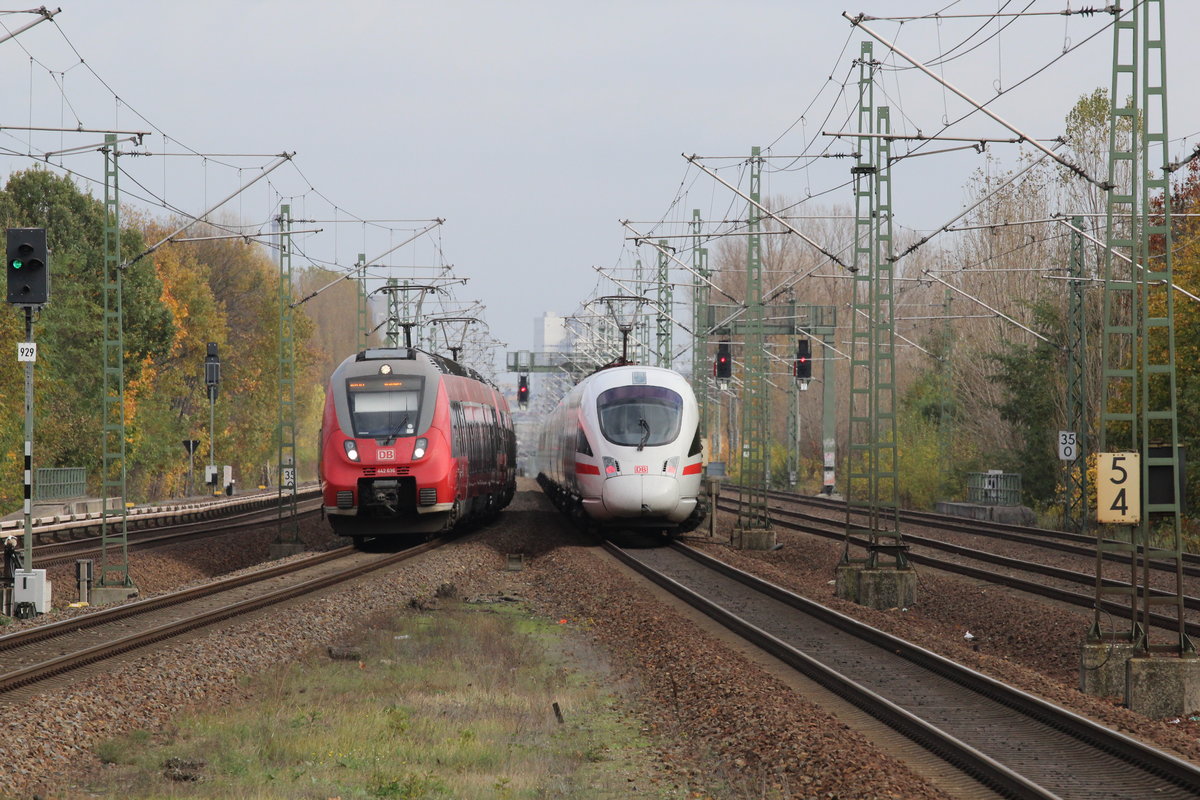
[0,540,446,702]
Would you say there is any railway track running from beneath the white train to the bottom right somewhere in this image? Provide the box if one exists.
[606,543,1200,800]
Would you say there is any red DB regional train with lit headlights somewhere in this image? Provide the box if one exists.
[319,348,516,543]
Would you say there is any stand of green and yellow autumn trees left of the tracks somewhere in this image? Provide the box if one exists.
[0,168,324,511]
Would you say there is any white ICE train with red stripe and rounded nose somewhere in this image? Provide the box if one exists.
[538,366,707,535]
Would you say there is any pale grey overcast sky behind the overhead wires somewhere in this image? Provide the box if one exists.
[0,0,1200,371]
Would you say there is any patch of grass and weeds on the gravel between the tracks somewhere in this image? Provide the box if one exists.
[88,604,688,800]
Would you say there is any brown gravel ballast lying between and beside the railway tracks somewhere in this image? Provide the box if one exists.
[9,482,1200,800]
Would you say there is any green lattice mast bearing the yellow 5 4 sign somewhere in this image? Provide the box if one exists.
[1090,0,1195,655]
